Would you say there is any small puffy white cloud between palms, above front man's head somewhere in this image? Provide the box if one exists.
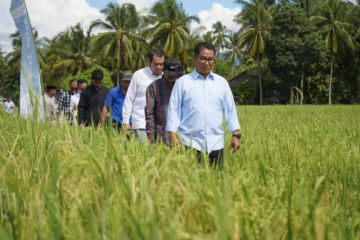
[192,3,241,34]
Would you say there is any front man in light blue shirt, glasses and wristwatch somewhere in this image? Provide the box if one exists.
[166,42,241,166]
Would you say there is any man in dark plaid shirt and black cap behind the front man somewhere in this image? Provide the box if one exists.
[145,58,184,144]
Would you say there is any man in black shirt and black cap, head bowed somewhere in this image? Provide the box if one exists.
[78,69,109,127]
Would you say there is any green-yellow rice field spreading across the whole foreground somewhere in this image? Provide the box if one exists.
[0,106,360,240]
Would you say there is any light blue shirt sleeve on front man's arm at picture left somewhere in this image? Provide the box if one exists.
[166,80,182,132]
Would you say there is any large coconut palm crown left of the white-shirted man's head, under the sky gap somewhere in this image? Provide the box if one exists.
[89,3,147,71]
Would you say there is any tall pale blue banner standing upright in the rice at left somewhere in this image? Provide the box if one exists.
[10,0,44,120]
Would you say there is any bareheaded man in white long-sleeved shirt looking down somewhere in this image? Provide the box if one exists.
[122,50,165,141]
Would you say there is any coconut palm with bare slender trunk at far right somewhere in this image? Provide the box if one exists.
[310,0,357,104]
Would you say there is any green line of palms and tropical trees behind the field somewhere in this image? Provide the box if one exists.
[0,0,360,104]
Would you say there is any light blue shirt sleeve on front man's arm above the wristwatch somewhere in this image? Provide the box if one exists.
[224,84,240,132]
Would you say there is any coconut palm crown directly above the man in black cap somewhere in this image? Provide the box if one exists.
[147,0,199,62]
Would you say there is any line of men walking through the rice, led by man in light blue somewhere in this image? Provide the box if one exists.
[47,42,241,166]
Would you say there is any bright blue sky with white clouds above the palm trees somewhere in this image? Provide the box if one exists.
[0,0,241,52]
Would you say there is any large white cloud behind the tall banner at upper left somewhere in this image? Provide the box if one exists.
[0,0,103,51]
